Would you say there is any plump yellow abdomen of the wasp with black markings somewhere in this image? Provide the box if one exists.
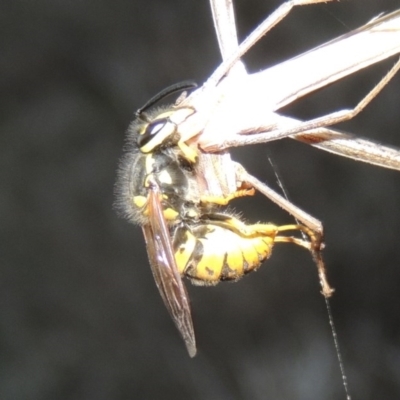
[174,218,276,285]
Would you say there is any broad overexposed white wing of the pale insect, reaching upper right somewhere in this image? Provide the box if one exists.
[238,10,400,110]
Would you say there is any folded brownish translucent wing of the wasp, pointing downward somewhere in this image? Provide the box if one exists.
[143,185,196,357]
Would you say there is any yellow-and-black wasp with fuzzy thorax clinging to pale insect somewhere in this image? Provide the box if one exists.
[117,82,332,357]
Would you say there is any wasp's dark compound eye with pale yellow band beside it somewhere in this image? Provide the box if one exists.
[137,118,176,153]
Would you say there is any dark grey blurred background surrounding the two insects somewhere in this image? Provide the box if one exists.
[0,0,400,400]
